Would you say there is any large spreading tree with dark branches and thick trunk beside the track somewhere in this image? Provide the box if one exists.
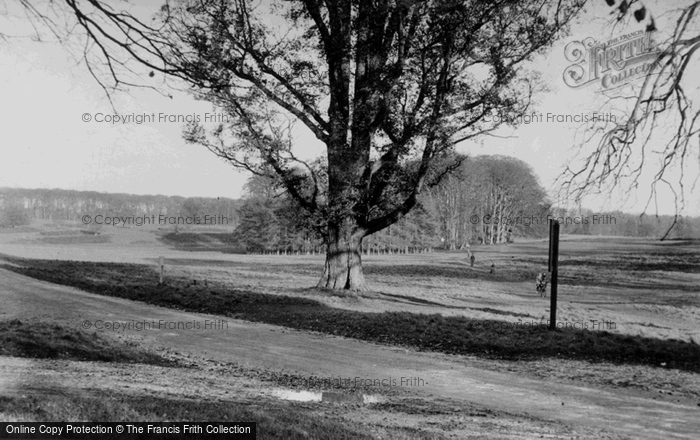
[13,0,585,290]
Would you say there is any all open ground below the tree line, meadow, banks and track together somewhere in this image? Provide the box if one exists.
[0,224,700,438]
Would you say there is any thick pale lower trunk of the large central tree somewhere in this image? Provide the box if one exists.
[316,219,369,292]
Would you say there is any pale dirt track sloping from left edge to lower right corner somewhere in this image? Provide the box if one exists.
[0,270,700,439]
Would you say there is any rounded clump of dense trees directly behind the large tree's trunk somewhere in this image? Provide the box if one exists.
[236,156,548,254]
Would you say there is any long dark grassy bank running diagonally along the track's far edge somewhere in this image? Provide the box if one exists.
[4,258,700,373]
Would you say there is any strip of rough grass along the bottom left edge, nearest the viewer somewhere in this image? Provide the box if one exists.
[0,393,434,440]
